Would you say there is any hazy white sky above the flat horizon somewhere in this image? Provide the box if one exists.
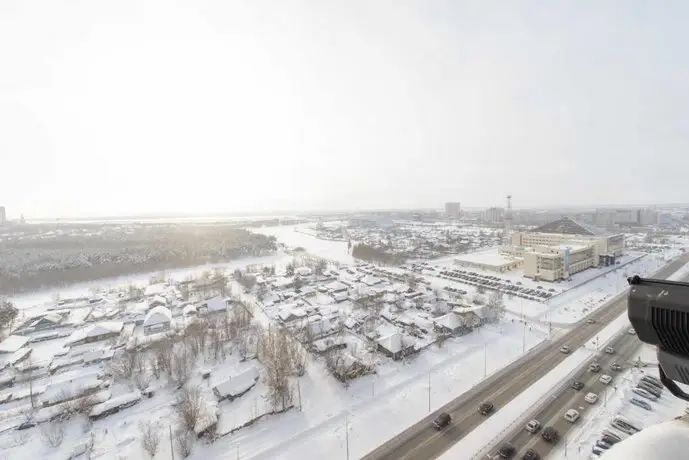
[0,0,689,217]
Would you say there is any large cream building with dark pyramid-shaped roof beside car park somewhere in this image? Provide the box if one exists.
[503,217,624,281]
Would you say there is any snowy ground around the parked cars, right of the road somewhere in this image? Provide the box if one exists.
[548,345,687,460]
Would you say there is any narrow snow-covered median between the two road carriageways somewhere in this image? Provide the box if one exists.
[439,348,593,460]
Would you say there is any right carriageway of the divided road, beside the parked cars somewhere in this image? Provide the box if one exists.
[489,332,641,459]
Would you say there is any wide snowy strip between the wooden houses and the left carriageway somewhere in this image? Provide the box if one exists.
[199,320,547,460]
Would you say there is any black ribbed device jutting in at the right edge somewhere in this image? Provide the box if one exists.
[627,276,689,401]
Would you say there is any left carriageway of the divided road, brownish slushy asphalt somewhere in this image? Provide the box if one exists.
[363,254,689,460]
